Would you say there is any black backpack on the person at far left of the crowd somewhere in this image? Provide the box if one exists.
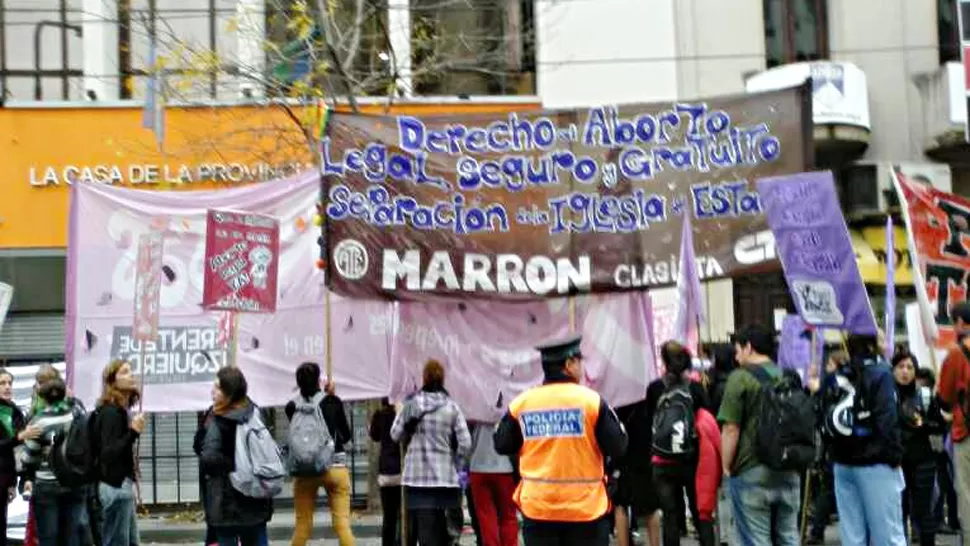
[48,405,98,488]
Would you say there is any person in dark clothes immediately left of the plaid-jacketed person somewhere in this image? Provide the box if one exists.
[370,398,401,546]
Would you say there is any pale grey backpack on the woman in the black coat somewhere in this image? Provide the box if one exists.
[229,408,286,499]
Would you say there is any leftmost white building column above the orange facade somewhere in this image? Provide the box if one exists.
[81,0,120,100]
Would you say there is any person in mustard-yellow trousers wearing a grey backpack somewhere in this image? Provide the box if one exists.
[284,362,354,546]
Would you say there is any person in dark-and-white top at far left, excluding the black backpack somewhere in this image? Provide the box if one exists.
[22,379,85,546]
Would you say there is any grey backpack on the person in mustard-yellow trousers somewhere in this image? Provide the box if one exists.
[287,392,334,476]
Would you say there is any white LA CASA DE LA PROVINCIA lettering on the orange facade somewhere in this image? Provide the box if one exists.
[27,162,313,188]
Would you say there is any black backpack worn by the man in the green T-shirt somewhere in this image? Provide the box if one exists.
[745,366,815,472]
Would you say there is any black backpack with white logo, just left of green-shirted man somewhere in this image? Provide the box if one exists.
[651,381,697,461]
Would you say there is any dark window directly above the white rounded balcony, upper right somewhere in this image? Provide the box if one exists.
[764,0,829,68]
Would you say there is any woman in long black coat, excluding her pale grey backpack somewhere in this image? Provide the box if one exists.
[199,367,273,546]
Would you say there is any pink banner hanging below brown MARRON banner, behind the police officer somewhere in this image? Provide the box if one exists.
[391,292,657,422]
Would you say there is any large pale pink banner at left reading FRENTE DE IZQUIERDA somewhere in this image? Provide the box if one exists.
[67,174,393,411]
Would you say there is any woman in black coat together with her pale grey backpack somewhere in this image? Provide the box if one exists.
[199,366,272,546]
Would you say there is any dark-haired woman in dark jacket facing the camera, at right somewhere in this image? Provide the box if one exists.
[893,353,946,546]
